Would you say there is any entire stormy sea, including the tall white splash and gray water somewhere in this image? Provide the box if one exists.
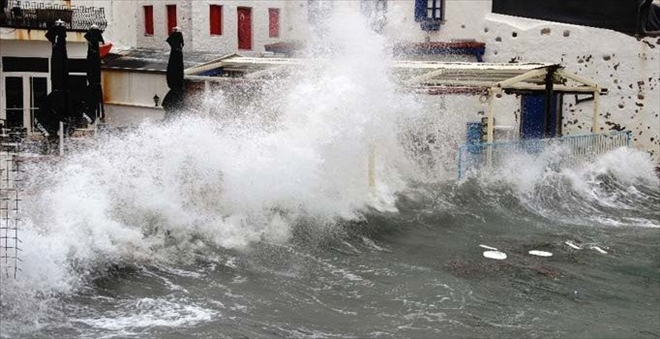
[0,11,660,338]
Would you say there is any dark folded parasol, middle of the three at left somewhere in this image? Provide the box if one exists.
[83,25,105,123]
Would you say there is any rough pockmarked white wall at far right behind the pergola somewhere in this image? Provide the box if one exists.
[478,14,660,161]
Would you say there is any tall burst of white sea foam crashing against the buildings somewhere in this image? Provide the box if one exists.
[0,15,454,328]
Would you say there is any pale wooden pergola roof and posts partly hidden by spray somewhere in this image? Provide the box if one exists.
[185,54,607,143]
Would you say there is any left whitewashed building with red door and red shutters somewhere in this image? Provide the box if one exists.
[93,0,307,125]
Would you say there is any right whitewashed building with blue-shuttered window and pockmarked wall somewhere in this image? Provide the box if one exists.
[335,0,660,161]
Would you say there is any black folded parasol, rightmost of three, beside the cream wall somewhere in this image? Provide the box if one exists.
[163,27,185,119]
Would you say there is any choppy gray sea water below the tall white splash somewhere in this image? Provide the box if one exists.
[2,155,660,338]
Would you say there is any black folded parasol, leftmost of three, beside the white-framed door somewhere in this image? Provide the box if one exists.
[35,20,72,136]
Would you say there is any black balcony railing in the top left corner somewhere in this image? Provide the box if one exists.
[0,0,108,31]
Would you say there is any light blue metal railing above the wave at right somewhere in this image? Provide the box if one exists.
[457,131,631,179]
